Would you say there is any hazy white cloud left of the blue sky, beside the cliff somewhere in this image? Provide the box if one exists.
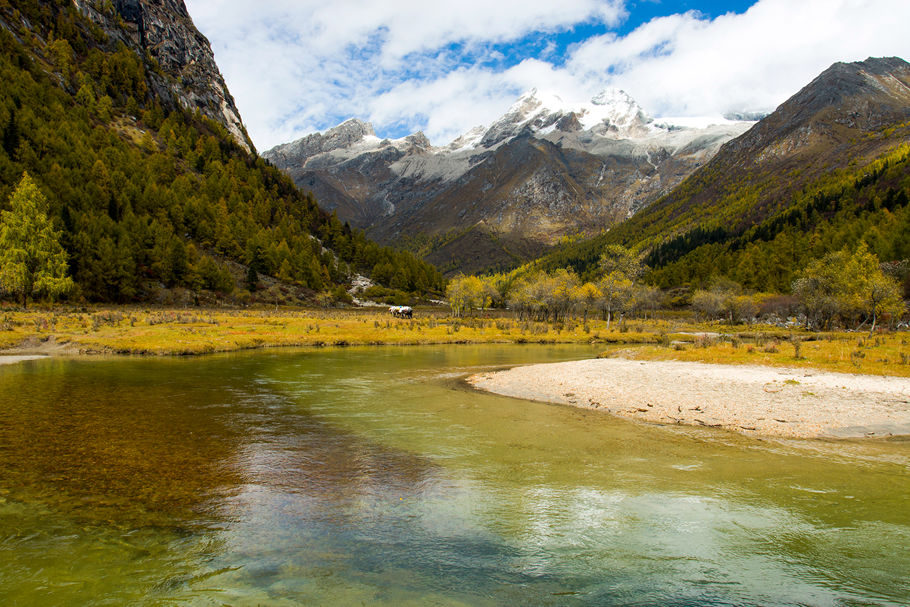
[187,0,623,149]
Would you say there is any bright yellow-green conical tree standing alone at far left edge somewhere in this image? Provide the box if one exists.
[0,173,73,306]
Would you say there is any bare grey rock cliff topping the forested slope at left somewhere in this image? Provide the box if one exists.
[73,0,253,151]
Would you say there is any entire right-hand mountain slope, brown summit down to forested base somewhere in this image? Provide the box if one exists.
[541,58,910,291]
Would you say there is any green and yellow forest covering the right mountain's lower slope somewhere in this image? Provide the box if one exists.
[536,140,910,297]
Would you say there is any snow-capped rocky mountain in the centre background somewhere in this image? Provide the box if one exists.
[263,89,753,270]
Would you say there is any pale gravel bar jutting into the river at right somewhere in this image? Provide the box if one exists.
[468,358,910,438]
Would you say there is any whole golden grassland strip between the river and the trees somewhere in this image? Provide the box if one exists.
[0,307,910,377]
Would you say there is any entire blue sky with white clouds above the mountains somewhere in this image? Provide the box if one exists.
[186,0,910,150]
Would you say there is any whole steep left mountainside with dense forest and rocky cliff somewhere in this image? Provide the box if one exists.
[0,0,441,302]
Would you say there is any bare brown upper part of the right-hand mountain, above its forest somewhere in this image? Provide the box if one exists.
[622,58,910,245]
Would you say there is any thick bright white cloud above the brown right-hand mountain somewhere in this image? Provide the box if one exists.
[566,0,910,115]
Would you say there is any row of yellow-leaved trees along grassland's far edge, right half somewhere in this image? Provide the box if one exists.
[446,243,910,330]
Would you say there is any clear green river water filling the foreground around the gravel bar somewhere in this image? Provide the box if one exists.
[0,346,910,607]
